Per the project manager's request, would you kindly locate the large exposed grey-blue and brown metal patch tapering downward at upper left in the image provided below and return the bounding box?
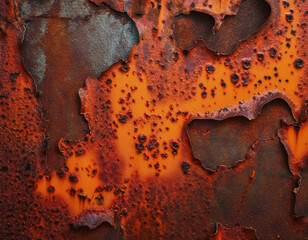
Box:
[20,0,138,169]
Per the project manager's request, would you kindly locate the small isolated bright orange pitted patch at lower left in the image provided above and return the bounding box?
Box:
[37,150,114,215]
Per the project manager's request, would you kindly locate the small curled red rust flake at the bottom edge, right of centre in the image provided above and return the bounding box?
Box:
[210,223,257,240]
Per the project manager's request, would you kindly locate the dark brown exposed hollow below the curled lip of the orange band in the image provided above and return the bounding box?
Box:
[187,100,294,170]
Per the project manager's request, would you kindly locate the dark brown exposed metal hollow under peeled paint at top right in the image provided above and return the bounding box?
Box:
[174,0,271,55]
